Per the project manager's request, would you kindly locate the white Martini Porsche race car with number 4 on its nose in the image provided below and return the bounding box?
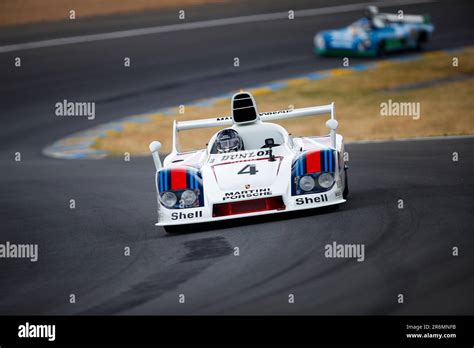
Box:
[150,92,349,232]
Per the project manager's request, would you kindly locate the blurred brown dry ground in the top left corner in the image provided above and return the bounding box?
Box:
[0,0,225,26]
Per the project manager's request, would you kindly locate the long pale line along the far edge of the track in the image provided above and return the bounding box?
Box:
[0,0,434,53]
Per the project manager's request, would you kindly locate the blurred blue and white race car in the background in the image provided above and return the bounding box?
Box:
[314,6,434,56]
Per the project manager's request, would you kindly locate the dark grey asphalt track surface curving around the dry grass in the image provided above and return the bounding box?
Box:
[0,1,474,314]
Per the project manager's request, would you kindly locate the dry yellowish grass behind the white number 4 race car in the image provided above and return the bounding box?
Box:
[96,48,474,154]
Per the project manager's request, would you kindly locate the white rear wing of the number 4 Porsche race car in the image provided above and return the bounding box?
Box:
[173,103,338,152]
